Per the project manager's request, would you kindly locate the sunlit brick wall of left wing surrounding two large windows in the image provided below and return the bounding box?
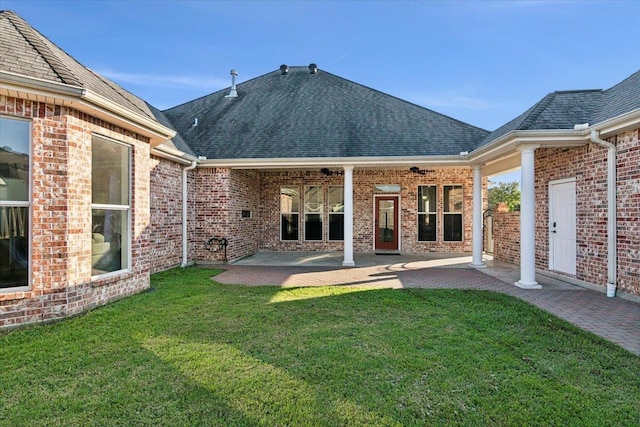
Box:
[0,96,149,328]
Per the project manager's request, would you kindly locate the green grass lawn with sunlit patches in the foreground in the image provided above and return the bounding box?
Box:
[0,268,640,426]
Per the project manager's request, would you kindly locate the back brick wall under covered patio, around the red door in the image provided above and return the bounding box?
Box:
[260,169,486,253]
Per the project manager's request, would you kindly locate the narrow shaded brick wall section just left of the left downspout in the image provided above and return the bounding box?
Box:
[149,156,184,273]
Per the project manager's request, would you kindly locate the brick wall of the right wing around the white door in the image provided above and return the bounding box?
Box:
[535,129,640,295]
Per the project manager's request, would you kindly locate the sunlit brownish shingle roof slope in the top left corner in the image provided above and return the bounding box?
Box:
[0,11,155,122]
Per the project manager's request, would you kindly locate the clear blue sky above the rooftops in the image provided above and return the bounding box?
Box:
[5,0,640,182]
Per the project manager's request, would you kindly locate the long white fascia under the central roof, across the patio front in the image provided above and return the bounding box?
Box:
[198,156,469,169]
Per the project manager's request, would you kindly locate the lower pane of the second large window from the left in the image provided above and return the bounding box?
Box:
[91,209,129,276]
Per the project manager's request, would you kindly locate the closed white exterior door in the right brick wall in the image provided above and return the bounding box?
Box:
[549,179,576,275]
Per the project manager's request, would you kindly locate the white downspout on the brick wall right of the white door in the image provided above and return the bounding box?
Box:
[591,130,618,297]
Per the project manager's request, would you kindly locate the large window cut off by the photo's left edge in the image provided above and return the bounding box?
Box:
[0,117,31,289]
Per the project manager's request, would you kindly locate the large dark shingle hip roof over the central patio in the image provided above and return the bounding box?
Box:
[164,67,487,159]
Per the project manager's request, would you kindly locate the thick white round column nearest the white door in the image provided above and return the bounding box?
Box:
[515,146,542,289]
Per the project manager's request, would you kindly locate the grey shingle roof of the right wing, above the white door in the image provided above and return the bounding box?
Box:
[480,71,640,145]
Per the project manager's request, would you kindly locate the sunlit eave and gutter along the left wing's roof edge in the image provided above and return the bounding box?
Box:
[0,71,176,146]
